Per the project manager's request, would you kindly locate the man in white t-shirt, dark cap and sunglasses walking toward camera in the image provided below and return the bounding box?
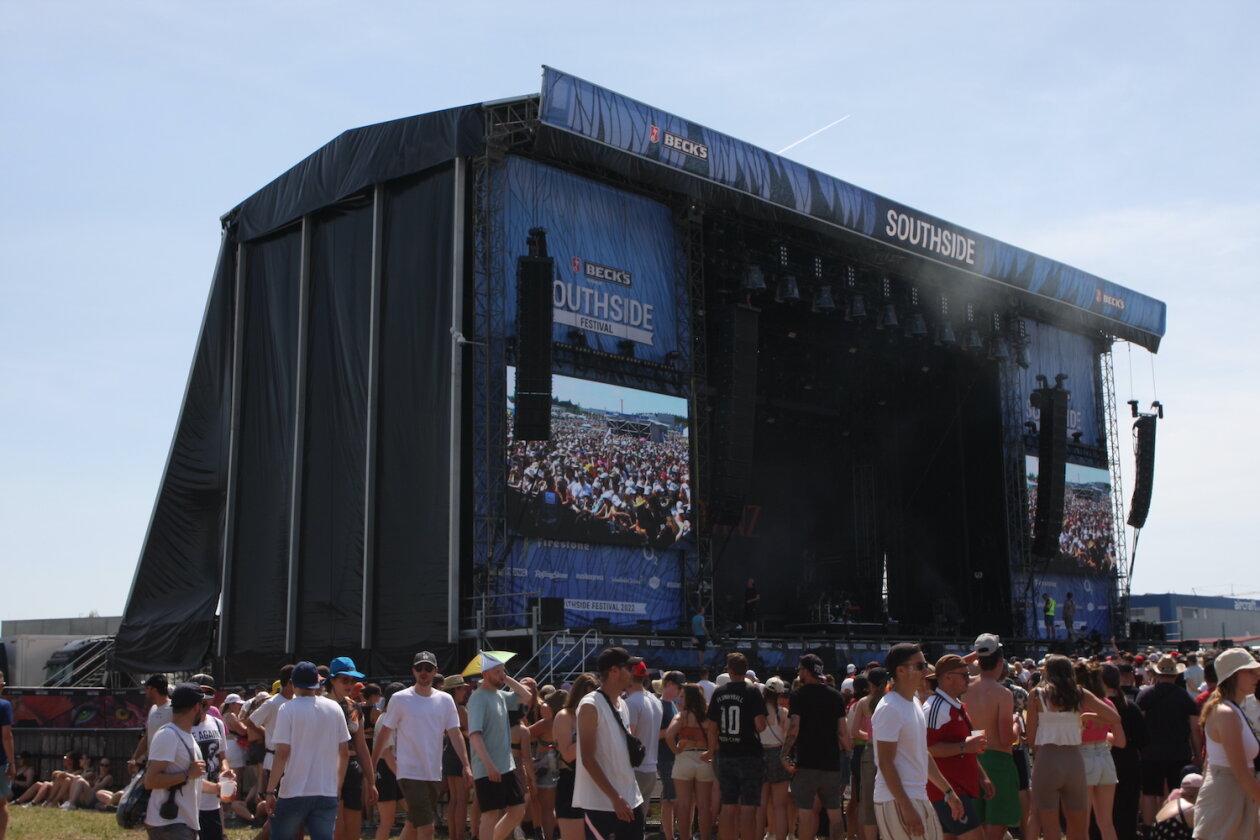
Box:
[372,650,473,840]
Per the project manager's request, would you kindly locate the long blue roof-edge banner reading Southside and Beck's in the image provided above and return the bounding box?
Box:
[539,68,1167,349]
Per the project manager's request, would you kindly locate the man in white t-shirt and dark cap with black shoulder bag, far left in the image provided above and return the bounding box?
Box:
[145,684,205,840]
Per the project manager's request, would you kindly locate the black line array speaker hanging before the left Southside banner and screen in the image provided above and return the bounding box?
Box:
[514,228,554,441]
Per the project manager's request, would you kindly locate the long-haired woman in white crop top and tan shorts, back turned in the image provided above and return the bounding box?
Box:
[1028,654,1120,840]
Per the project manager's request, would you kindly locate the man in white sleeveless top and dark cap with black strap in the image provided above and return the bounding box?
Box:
[573,647,644,840]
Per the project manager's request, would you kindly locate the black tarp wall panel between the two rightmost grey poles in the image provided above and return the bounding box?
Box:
[369,170,455,674]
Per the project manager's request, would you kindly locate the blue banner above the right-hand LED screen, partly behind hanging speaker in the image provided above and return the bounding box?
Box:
[1019,321,1105,447]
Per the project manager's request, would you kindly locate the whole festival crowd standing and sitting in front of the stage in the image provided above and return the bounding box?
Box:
[5,633,1260,840]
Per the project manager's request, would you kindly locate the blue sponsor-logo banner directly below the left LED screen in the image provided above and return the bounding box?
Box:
[503,536,683,630]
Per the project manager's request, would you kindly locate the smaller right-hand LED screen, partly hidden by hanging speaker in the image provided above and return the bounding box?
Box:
[1024,455,1115,572]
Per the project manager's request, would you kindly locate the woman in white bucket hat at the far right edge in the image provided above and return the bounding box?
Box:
[1194,647,1260,840]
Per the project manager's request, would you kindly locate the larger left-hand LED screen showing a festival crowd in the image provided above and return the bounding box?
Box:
[507,368,693,548]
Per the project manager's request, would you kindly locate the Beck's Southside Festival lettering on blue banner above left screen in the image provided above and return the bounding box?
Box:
[552,257,656,346]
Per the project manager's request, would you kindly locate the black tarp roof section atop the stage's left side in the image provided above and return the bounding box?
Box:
[223,105,485,242]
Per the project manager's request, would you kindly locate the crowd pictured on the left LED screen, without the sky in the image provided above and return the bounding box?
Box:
[507,412,692,548]
